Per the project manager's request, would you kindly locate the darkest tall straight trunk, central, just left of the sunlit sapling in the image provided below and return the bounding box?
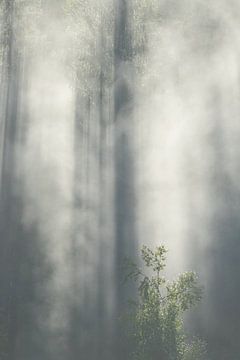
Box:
[114,0,137,358]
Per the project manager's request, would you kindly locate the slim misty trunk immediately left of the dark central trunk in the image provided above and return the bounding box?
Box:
[97,27,114,360]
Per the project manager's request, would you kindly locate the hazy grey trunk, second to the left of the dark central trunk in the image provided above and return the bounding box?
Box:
[69,83,94,360]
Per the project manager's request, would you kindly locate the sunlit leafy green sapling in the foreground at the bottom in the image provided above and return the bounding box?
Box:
[123,246,206,360]
